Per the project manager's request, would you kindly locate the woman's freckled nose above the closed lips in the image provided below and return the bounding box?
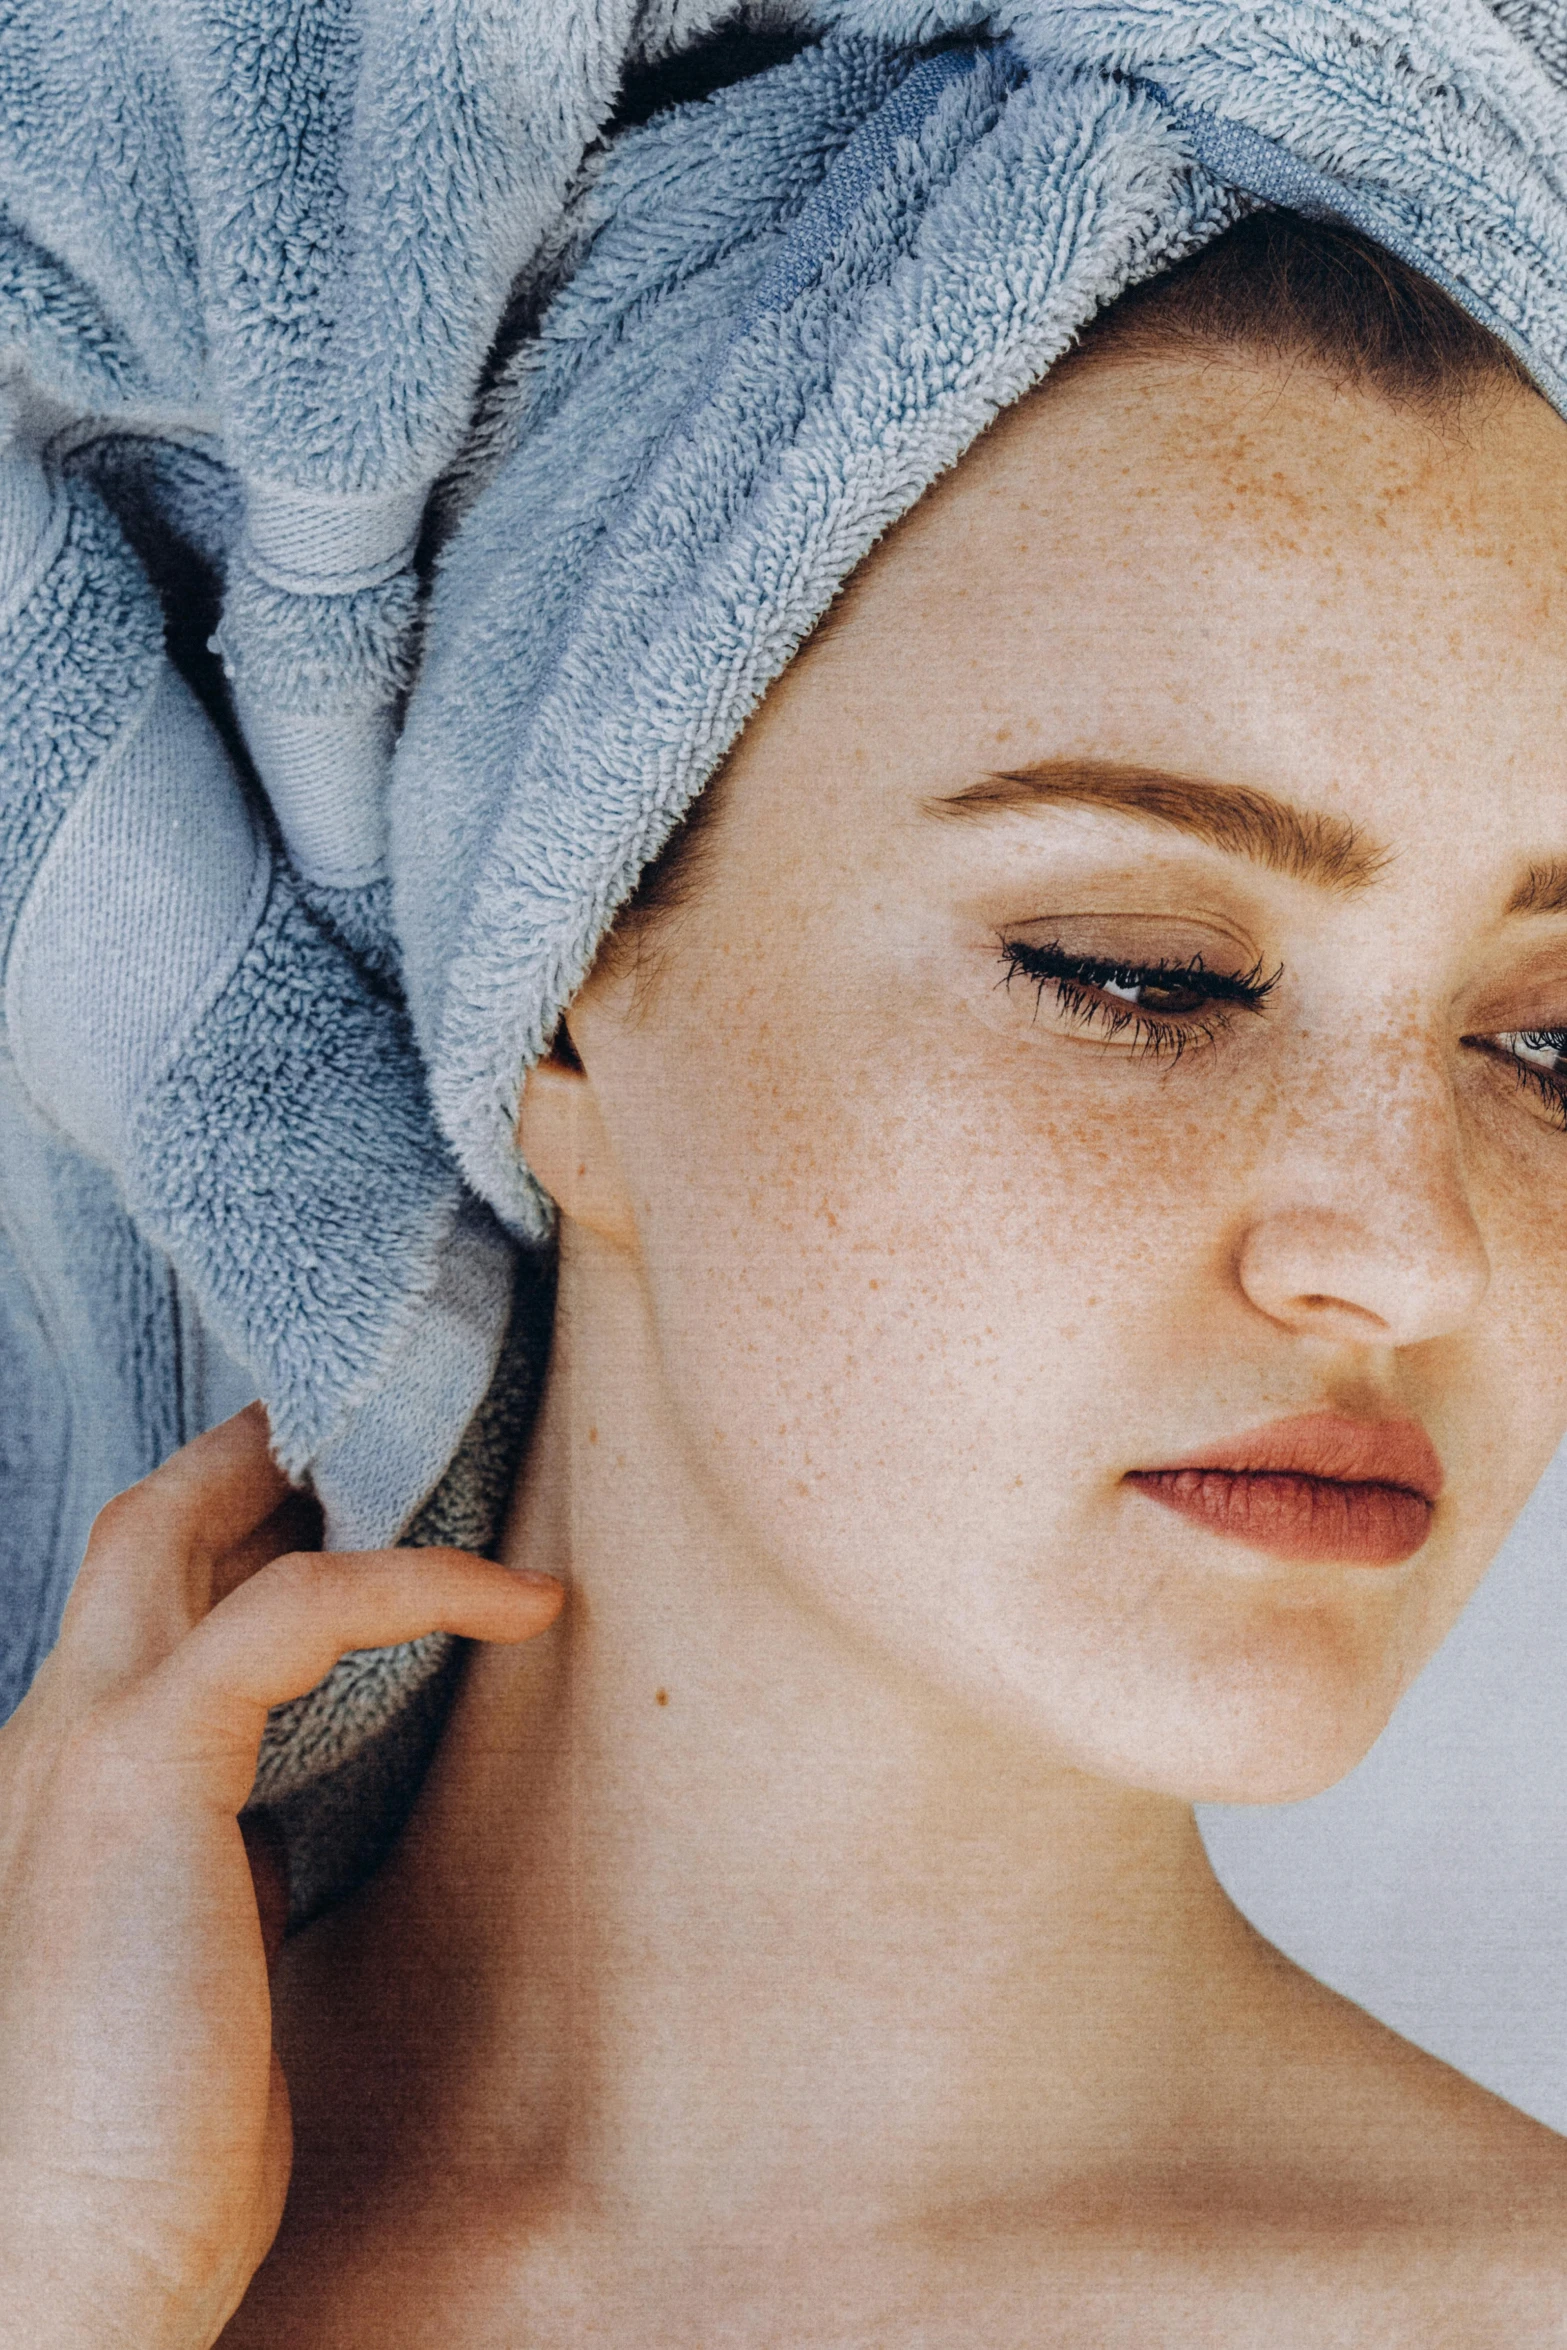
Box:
[1236,1088,1489,1347]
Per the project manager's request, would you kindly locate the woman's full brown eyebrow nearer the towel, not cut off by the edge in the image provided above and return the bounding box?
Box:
[926,759,1390,905]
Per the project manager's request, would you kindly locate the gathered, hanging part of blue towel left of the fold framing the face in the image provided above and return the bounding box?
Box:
[0,0,779,1544]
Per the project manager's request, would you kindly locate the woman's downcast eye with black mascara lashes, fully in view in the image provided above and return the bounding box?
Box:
[1001,938,1280,1055]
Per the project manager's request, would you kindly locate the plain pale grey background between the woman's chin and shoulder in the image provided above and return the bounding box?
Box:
[1198,1445,1567,2131]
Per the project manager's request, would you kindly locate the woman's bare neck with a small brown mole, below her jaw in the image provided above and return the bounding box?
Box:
[312,1253,1257,2242]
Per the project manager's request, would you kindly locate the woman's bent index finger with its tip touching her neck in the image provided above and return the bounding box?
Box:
[139,1549,564,1810]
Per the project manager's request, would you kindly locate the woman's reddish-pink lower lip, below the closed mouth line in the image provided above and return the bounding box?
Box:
[1125,1469,1431,1567]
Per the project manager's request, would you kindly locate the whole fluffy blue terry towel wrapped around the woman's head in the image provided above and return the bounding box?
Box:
[0,0,1567,1802]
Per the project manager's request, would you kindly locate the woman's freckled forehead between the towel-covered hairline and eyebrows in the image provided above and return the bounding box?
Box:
[738,355,1567,864]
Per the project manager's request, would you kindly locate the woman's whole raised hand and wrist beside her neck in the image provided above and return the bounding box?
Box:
[0,1405,561,2350]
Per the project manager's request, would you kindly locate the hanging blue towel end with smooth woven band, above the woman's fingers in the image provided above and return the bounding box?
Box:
[0,402,510,1542]
